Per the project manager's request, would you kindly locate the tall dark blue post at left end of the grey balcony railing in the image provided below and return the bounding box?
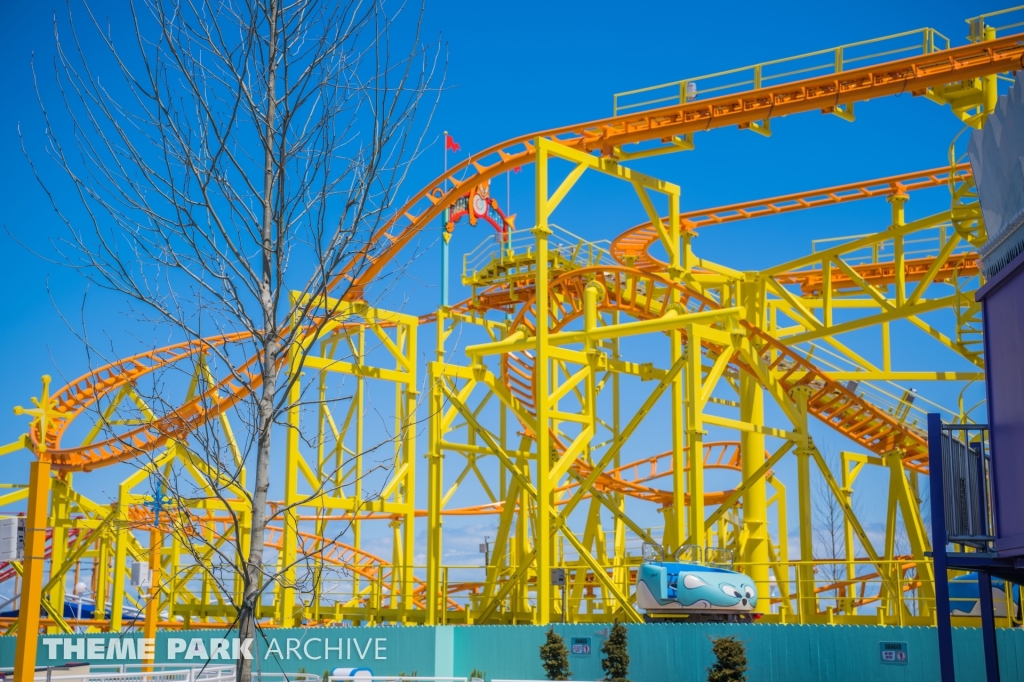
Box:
[928,414,954,682]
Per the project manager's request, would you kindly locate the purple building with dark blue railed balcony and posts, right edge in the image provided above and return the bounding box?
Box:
[928,242,1024,682]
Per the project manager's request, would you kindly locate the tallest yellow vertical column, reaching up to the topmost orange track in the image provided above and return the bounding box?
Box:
[534,138,554,625]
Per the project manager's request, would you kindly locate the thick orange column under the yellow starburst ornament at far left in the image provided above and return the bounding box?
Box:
[14,461,50,682]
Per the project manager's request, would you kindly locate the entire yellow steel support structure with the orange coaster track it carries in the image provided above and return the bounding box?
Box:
[0,13,1024,663]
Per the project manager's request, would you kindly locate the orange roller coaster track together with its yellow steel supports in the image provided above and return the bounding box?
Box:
[0,21,1011,647]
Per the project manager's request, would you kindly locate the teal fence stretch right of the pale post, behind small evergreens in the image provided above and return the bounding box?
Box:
[455,624,1024,682]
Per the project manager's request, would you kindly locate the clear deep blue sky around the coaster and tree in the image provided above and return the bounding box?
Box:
[0,0,1004,561]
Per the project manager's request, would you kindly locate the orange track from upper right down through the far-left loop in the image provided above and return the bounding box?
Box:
[29,35,1024,470]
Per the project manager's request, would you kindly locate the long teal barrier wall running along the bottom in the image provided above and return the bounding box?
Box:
[0,624,1024,682]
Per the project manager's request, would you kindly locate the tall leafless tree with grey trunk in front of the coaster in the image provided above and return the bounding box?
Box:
[23,0,442,682]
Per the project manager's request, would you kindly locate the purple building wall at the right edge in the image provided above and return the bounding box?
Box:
[976,246,1024,557]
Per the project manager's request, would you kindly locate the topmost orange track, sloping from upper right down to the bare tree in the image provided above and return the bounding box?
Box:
[332,34,1024,300]
